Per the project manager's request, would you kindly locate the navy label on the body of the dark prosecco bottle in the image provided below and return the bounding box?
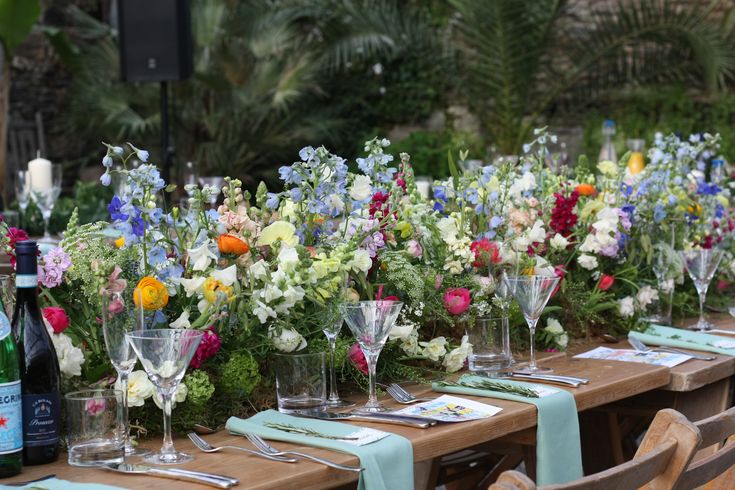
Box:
[23,393,61,446]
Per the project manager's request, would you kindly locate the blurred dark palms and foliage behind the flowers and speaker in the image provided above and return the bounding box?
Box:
[4,0,735,234]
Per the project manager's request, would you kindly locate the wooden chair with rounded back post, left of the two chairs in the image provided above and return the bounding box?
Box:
[488,408,702,490]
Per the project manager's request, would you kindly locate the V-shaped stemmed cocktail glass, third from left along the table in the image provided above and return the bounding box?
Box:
[503,275,559,374]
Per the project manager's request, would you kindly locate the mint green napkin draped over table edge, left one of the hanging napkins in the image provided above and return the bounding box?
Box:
[226,410,413,490]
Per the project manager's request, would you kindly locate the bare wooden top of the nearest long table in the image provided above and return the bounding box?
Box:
[0,356,669,490]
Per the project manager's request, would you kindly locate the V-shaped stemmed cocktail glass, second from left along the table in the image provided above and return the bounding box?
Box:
[339,301,403,412]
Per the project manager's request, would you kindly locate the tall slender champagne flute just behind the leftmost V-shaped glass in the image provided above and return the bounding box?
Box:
[100,289,150,456]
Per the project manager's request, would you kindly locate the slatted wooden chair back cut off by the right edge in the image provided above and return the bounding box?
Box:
[676,407,735,490]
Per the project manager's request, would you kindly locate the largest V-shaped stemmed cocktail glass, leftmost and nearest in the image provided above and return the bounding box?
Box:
[126,328,204,464]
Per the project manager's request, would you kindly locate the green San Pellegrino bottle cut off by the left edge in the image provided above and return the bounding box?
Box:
[0,290,23,478]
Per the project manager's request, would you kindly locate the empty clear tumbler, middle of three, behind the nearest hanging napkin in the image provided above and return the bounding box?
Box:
[275,352,327,413]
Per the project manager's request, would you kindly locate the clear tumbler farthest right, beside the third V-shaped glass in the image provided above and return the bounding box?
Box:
[466,318,510,376]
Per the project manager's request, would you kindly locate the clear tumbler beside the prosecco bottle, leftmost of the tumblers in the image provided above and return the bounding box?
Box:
[64,390,125,466]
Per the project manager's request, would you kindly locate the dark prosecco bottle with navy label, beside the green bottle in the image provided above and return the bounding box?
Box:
[12,240,61,465]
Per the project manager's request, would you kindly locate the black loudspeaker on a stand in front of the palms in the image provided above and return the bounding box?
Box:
[118,0,193,82]
